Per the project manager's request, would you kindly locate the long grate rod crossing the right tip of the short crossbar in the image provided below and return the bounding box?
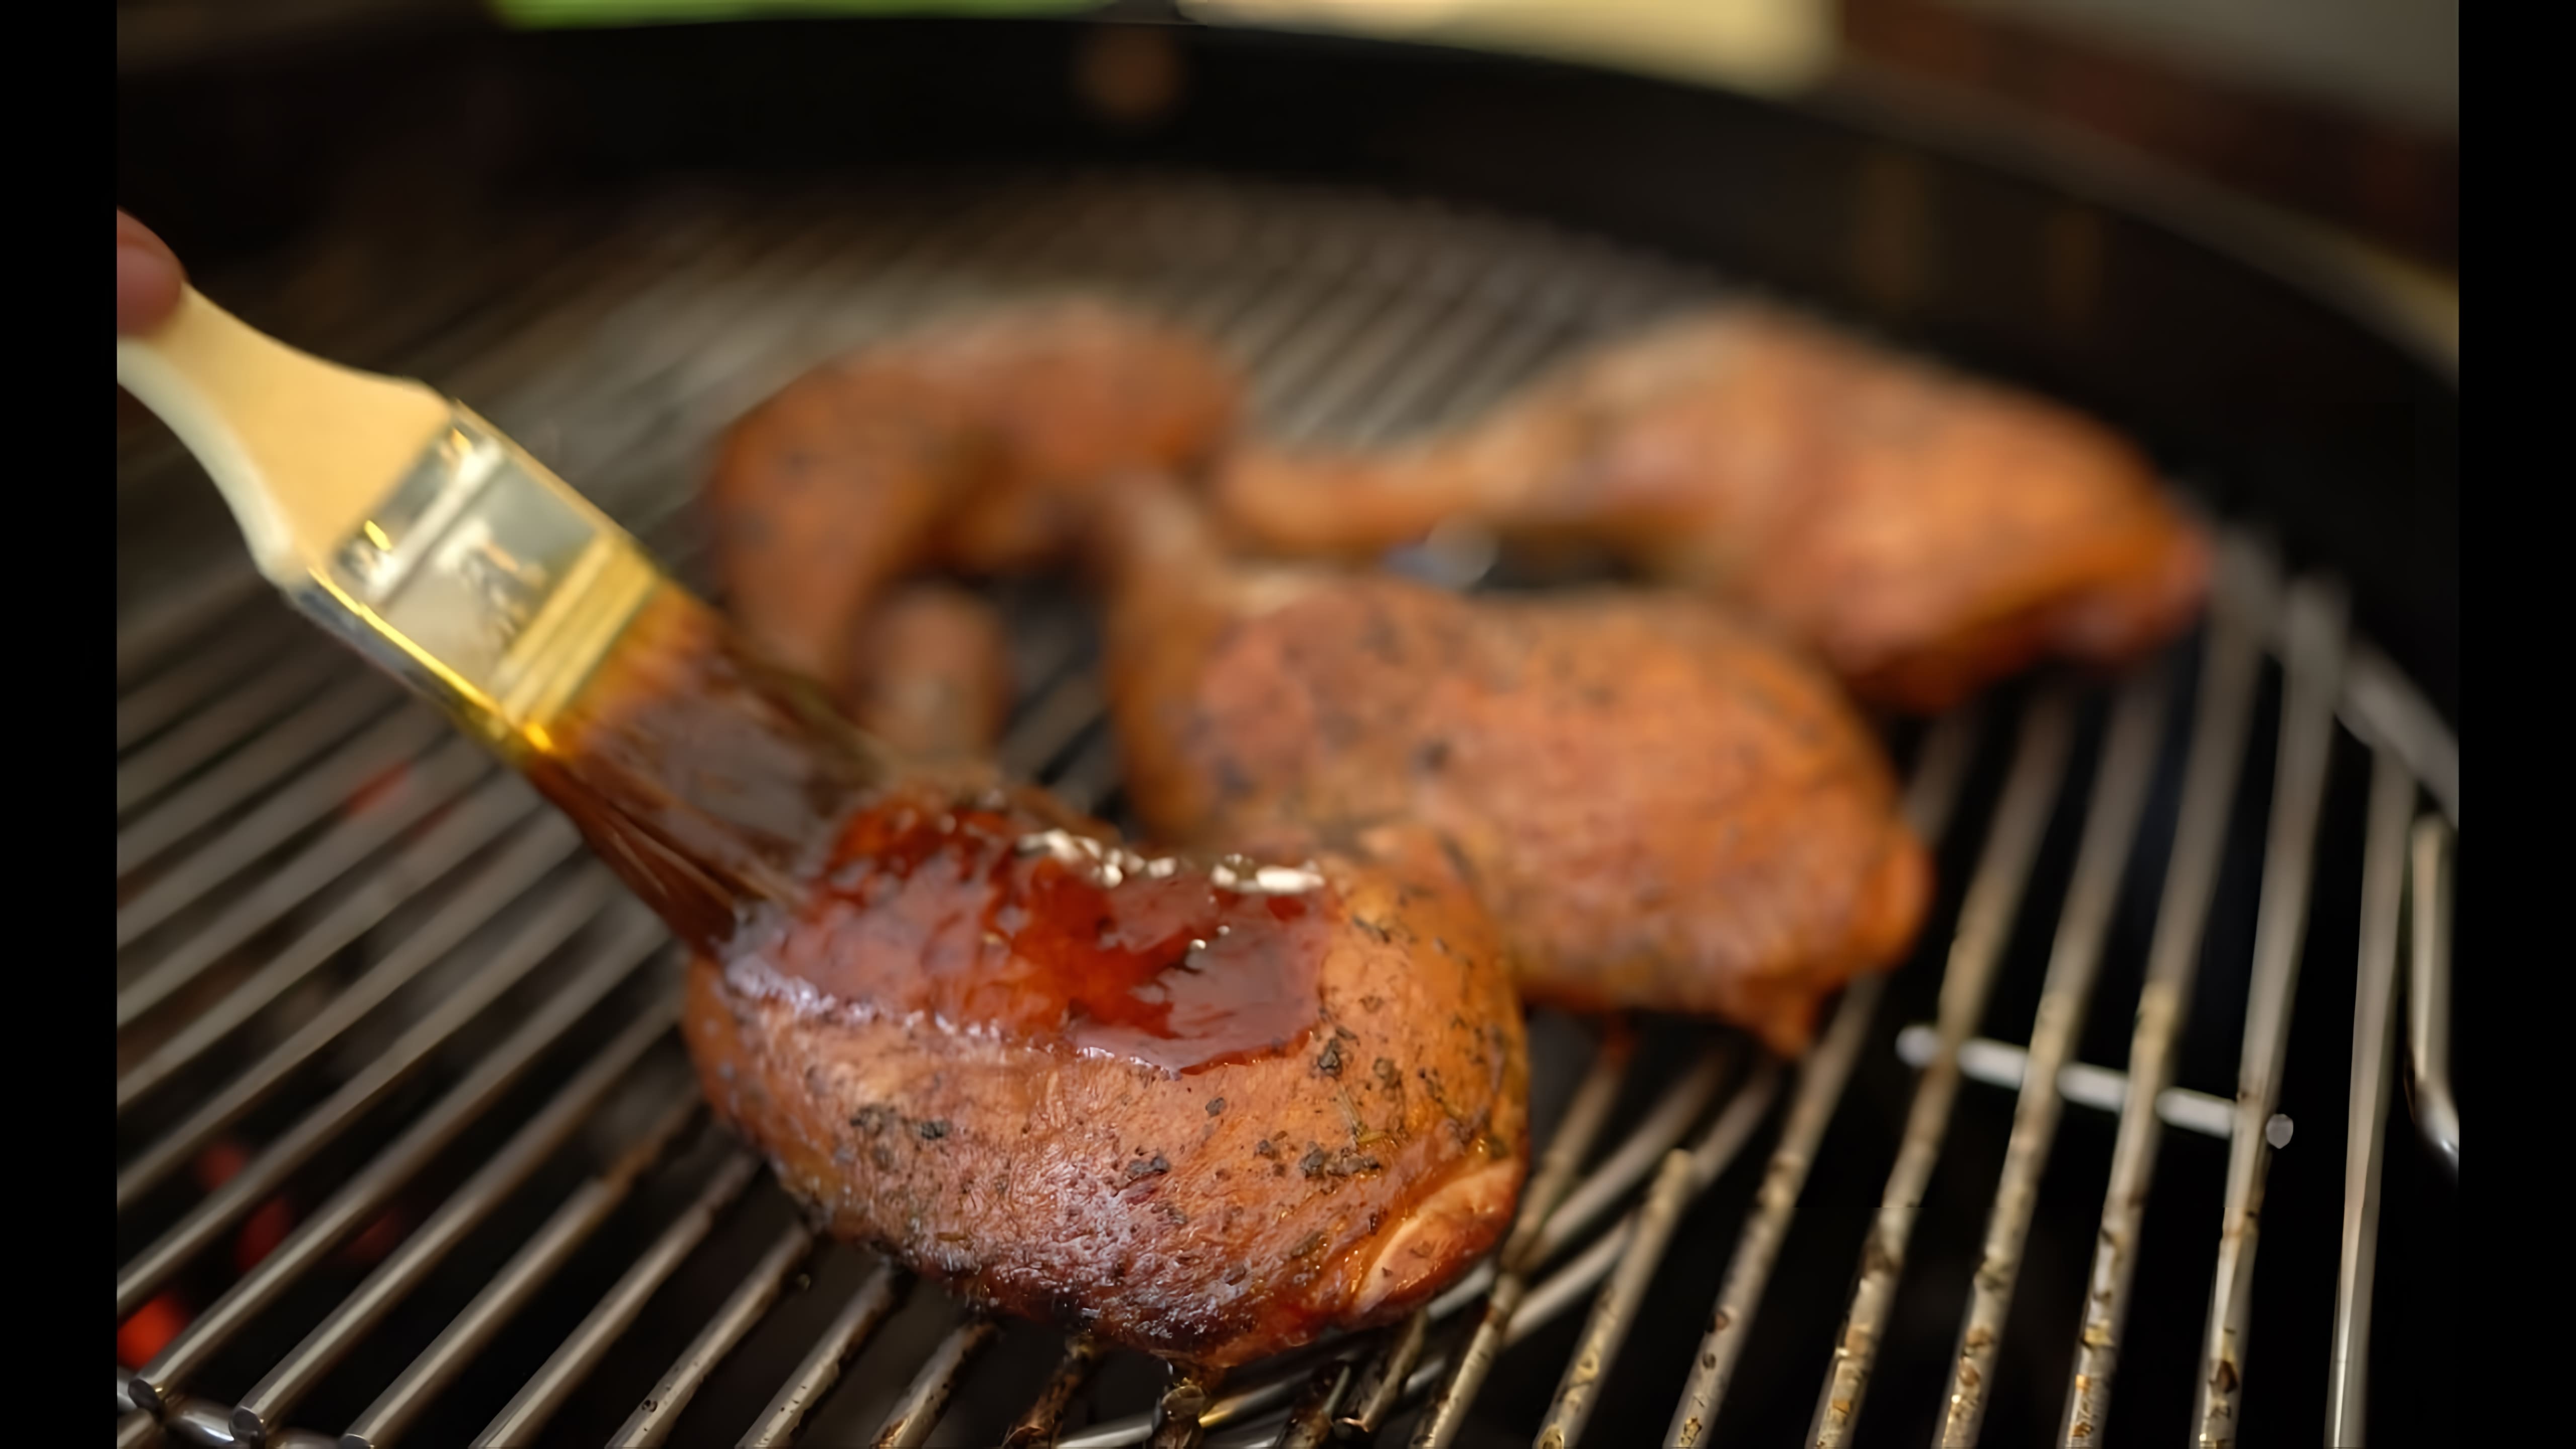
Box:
[2192,572,2349,1449]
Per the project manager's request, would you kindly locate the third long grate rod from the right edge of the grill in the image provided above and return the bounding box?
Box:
[2061,541,2272,1449]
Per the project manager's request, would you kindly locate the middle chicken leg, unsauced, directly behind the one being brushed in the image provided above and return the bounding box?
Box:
[1100,482,1929,1052]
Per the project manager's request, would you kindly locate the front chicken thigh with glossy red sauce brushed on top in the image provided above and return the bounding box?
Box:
[685,778,1527,1369]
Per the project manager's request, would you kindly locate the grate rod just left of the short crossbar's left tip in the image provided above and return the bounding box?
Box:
[1664,706,1978,1449]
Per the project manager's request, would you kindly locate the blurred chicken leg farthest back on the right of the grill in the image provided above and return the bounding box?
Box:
[1219,307,2208,711]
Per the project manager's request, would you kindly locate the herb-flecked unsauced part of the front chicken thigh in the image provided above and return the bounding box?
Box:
[683,815,1527,1369]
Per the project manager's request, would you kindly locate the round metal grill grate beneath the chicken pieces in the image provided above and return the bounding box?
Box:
[116,178,2457,1449]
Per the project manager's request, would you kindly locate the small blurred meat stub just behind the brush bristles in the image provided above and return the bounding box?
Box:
[850,583,1010,761]
